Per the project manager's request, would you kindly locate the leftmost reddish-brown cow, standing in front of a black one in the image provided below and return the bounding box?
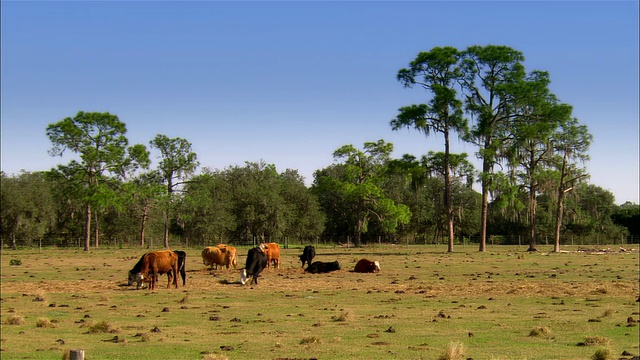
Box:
[129,250,178,290]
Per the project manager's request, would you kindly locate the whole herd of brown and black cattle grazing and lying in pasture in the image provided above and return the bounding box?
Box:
[128,243,380,290]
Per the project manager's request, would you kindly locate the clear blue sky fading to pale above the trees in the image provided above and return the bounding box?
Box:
[1,0,640,204]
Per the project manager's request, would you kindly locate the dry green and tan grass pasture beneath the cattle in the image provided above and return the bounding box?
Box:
[0,245,640,360]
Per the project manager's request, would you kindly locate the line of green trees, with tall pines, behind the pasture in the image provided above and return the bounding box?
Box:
[0,45,640,251]
